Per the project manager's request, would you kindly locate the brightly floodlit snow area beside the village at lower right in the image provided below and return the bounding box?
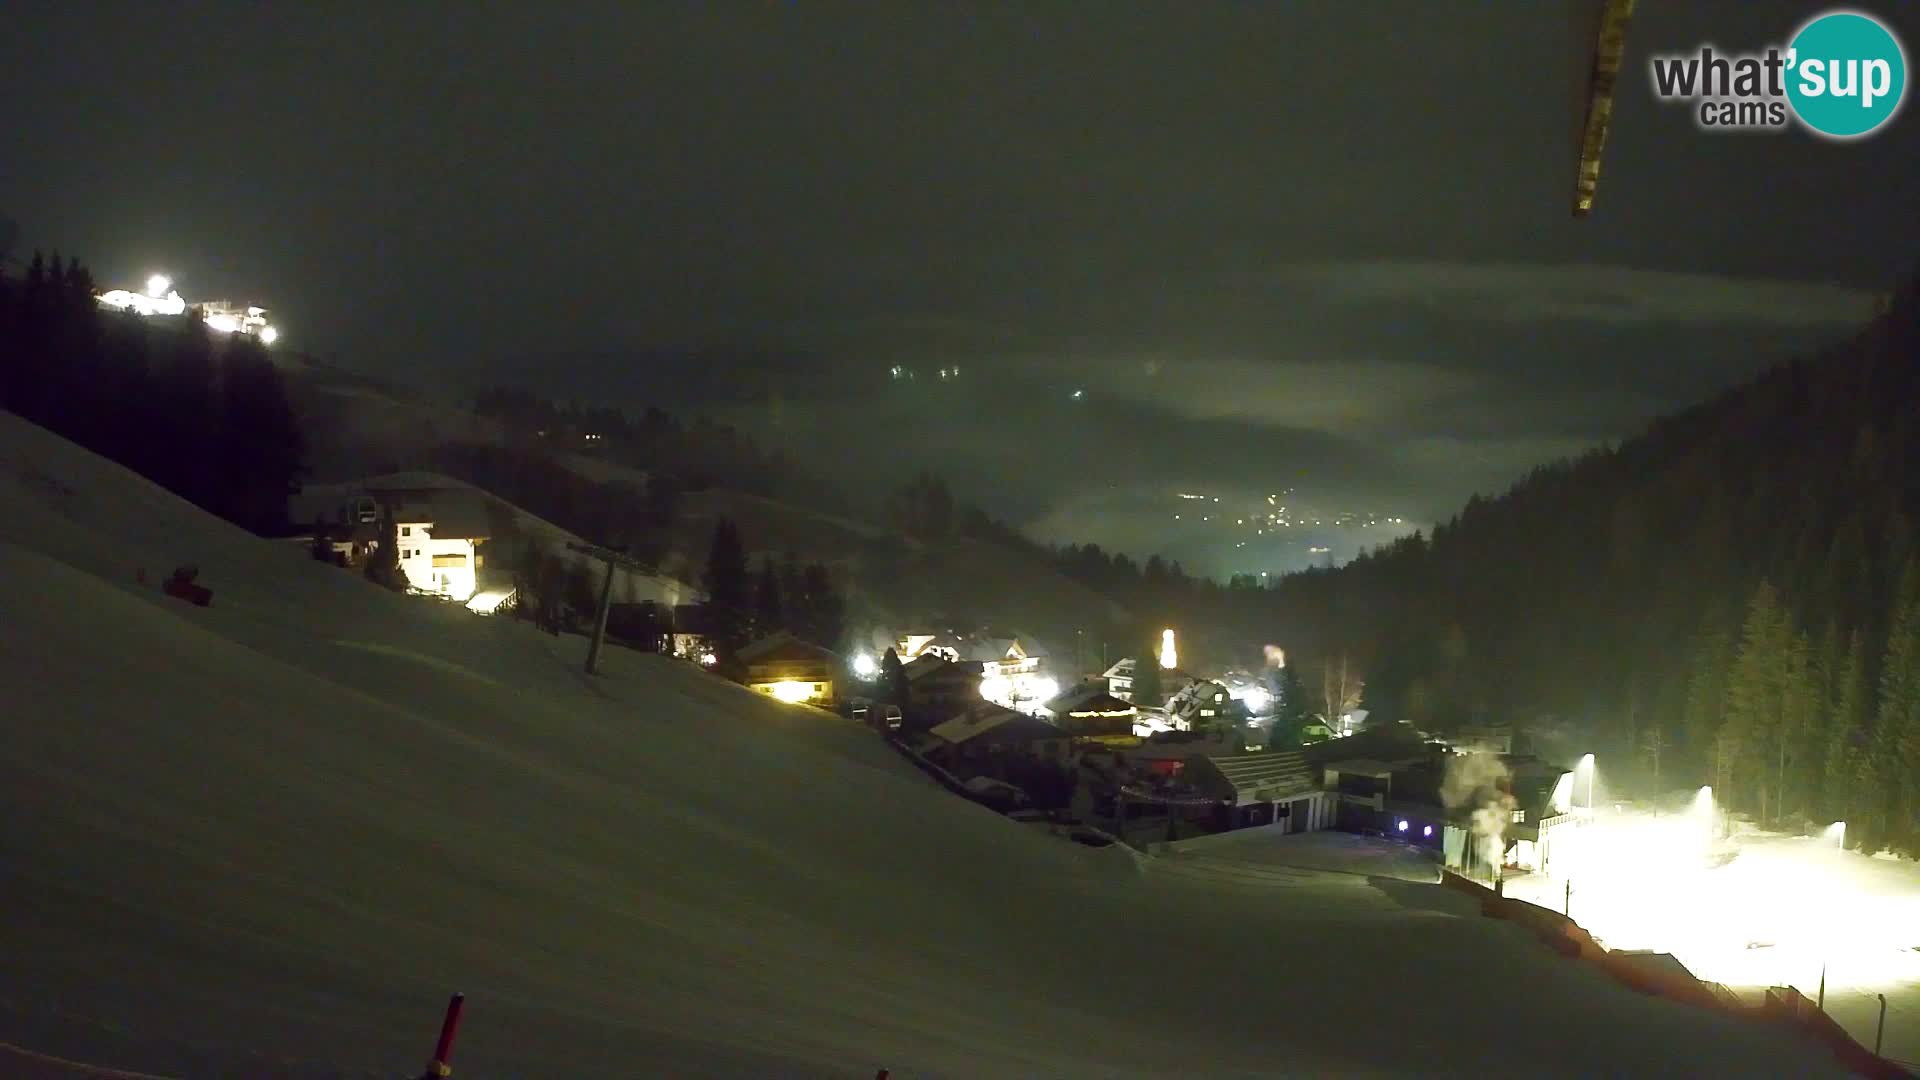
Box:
[1503,788,1920,1061]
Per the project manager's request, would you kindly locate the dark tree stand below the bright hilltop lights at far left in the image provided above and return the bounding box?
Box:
[0,252,305,534]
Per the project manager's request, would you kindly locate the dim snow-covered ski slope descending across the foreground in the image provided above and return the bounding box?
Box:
[0,413,1834,1078]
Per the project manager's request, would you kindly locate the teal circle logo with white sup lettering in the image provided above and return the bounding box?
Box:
[1788,12,1907,138]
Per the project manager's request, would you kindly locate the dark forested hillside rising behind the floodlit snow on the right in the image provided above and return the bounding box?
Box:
[1277,265,1920,847]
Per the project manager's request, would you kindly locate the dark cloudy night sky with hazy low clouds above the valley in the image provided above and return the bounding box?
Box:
[0,0,1920,573]
